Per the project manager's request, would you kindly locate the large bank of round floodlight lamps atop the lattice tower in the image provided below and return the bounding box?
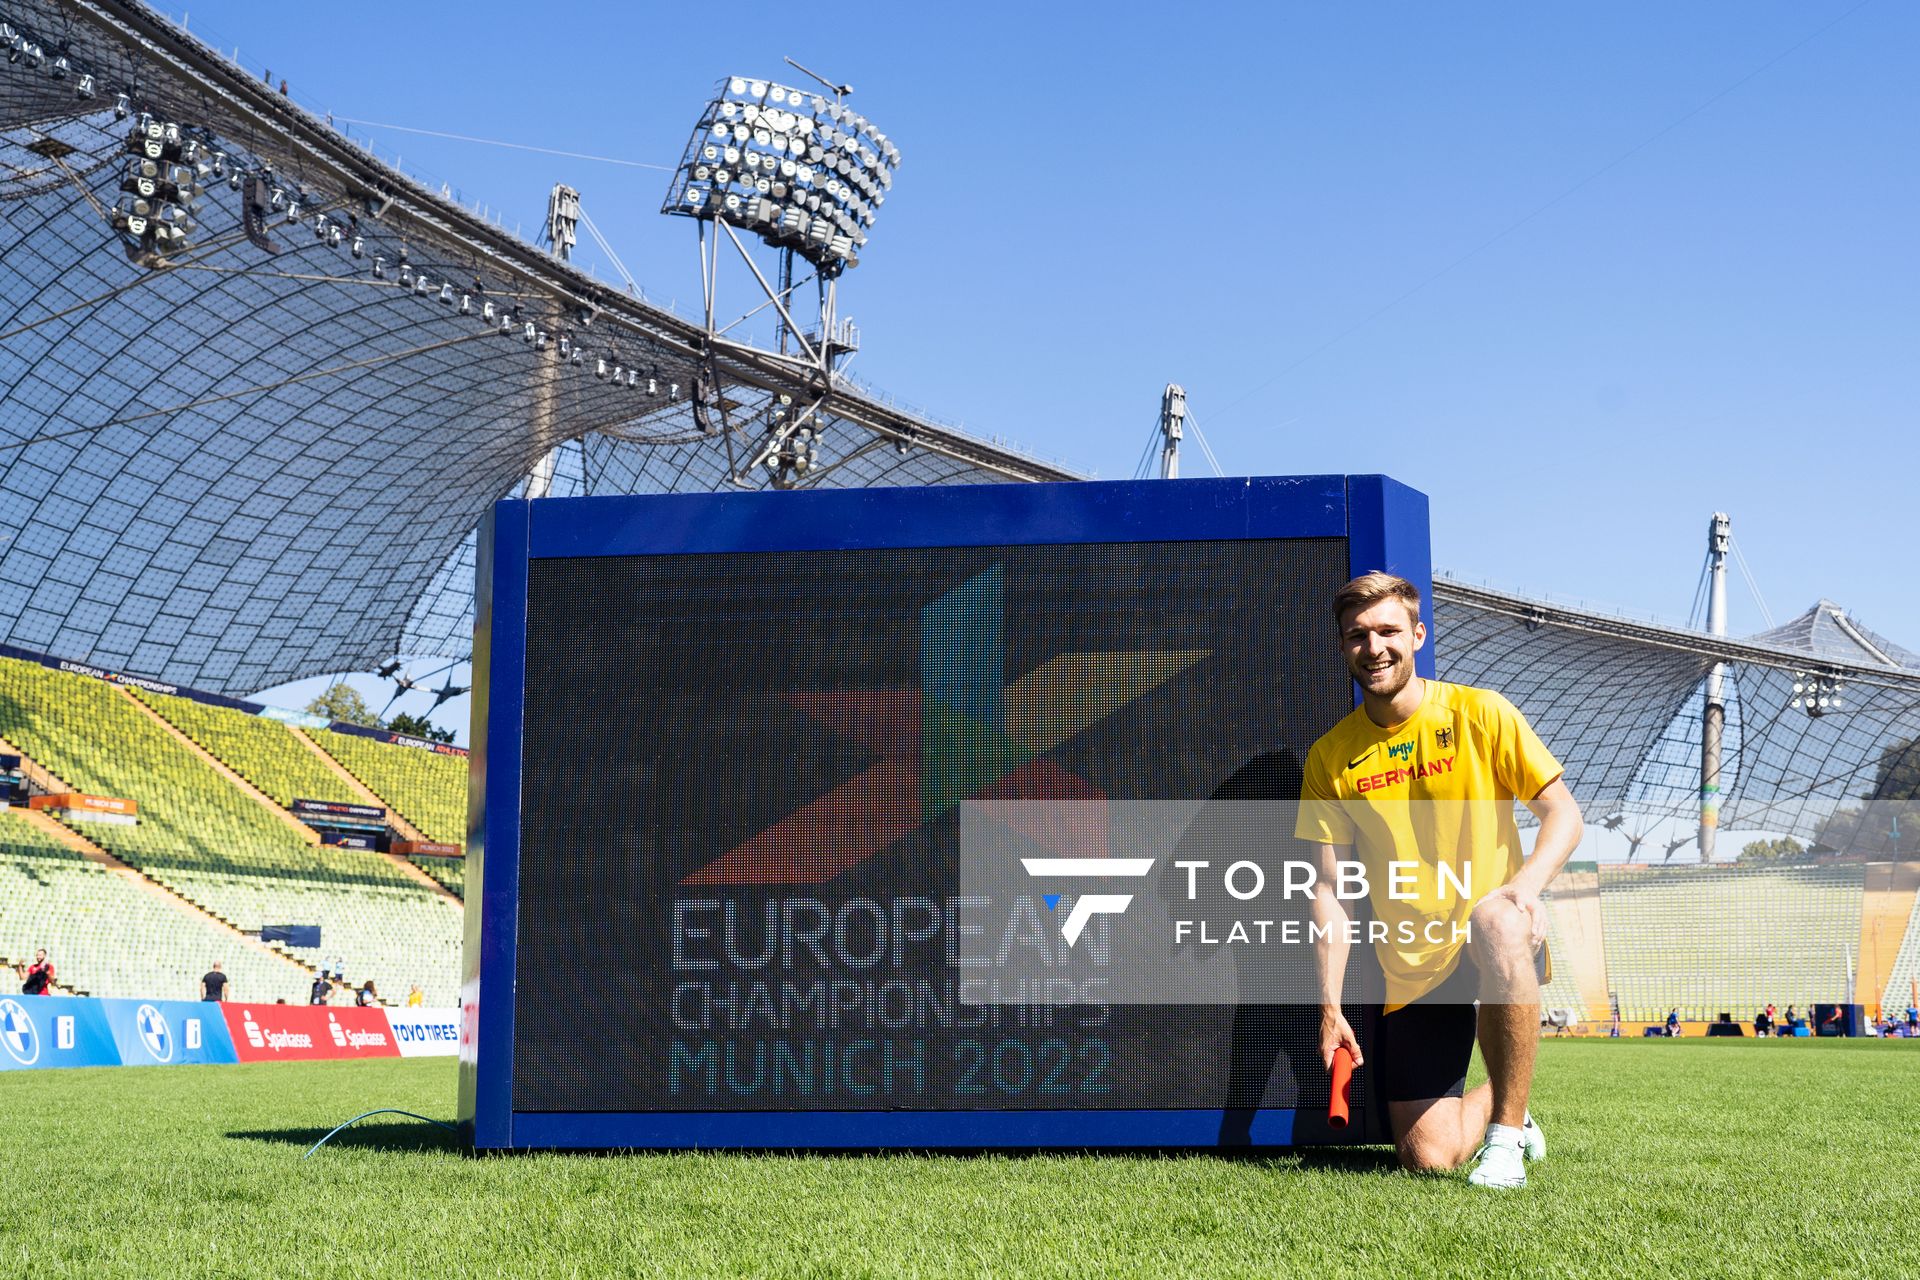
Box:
[660,77,900,278]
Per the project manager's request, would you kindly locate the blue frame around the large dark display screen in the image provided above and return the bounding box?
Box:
[459,476,1434,1151]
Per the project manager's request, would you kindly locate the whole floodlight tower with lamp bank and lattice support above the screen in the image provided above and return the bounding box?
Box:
[660,58,900,487]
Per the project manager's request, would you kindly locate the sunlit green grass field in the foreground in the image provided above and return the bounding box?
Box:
[0,1040,1920,1280]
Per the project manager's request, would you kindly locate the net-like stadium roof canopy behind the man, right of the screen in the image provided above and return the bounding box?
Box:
[1434,580,1920,844]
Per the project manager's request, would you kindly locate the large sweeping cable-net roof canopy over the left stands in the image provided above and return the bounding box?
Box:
[0,0,1064,693]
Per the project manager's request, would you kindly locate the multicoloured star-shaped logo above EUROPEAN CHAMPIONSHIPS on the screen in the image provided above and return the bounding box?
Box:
[680,564,1210,885]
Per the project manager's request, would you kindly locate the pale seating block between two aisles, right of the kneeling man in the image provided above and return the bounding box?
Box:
[1599,864,1862,1021]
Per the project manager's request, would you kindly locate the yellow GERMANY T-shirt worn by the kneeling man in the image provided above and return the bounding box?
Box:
[1294,679,1561,1011]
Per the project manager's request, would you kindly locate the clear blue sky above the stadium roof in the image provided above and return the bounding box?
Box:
[175,0,1920,736]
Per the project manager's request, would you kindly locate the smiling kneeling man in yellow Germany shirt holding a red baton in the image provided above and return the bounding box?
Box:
[1296,574,1584,1188]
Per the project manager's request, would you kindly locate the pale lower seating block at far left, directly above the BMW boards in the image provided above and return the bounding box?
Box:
[0,812,305,1000]
